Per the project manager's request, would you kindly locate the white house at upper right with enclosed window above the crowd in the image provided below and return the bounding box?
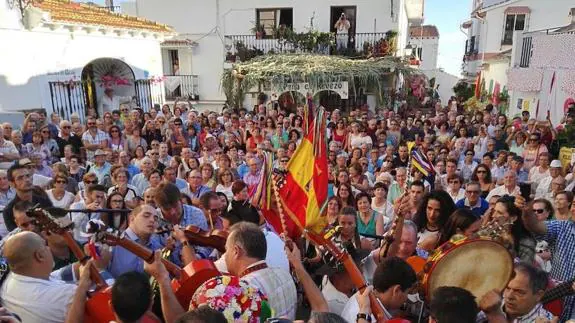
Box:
[461,0,575,110]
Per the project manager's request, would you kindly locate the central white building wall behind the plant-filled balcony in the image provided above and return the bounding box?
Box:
[122,0,424,109]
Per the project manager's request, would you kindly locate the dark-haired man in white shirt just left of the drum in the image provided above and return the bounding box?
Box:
[342,257,417,322]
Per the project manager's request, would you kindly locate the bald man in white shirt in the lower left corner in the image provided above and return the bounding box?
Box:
[0,232,92,323]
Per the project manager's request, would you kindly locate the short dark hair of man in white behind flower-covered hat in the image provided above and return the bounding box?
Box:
[229,221,267,260]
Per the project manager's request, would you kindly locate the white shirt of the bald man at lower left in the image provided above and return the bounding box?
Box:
[0,272,76,323]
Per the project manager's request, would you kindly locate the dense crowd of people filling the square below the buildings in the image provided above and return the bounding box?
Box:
[0,98,575,323]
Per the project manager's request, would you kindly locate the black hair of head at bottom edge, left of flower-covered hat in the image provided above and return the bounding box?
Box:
[112,271,152,322]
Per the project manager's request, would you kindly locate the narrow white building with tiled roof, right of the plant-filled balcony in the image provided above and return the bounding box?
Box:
[408,25,459,104]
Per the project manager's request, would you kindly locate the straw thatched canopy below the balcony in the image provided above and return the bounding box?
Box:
[222,54,416,107]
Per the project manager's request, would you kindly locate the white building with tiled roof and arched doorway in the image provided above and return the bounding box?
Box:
[0,0,174,121]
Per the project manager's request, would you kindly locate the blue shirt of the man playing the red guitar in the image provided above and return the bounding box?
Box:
[108,228,162,277]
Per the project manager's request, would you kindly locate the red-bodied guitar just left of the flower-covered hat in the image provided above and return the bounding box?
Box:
[92,231,221,308]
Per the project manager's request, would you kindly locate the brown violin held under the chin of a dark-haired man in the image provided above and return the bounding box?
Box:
[156,218,229,253]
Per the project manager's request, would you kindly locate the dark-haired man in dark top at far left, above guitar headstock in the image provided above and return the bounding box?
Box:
[2,159,52,231]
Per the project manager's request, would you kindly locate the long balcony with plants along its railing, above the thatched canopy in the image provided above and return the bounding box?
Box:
[226,32,397,62]
